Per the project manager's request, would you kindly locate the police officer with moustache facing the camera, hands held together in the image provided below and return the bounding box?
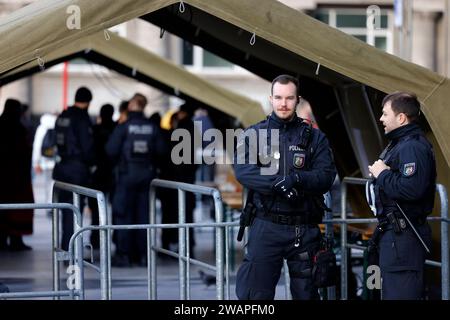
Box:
[234,75,336,300]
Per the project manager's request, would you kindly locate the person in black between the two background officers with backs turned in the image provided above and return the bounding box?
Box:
[88,104,116,249]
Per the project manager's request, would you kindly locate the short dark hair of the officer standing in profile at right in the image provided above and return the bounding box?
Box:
[381,91,420,122]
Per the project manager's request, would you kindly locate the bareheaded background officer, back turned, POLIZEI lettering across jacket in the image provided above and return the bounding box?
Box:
[106,93,166,267]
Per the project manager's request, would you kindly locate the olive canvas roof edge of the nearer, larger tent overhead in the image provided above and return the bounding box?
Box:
[0,0,450,166]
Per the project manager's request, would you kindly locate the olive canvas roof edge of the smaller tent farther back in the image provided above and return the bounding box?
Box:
[0,32,265,126]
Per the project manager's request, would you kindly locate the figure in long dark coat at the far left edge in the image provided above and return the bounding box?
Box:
[0,99,34,251]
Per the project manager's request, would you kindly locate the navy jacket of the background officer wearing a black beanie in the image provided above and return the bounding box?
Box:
[53,107,95,186]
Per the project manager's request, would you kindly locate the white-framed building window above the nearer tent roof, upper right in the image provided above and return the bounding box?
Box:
[314,8,394,53]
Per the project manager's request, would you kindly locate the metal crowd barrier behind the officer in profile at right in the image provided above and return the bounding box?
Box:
[336,177,450,300]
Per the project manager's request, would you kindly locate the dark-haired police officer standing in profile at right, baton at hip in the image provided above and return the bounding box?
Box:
[369,92,436,300]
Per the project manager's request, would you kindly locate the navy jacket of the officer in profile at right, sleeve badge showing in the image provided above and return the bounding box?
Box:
[374,123,436,222]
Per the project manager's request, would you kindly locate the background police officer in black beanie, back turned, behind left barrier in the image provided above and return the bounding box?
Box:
[53,87,95,250]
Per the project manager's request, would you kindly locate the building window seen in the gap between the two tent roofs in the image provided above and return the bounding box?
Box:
[181,40,236,71]
